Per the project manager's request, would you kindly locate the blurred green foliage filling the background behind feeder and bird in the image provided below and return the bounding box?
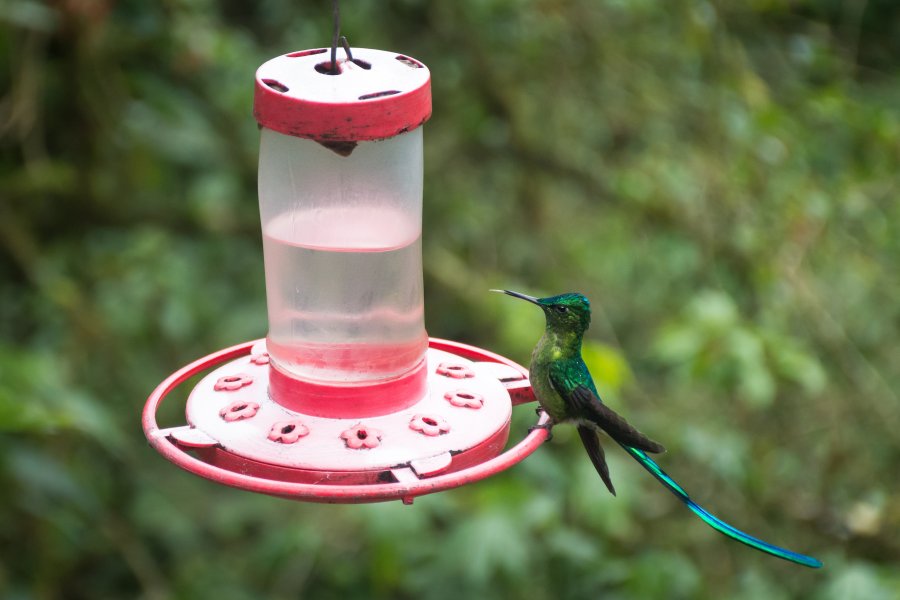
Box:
[0,0,900,600]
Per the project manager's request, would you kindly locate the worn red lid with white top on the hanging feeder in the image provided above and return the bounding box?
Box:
[253,48,431,141]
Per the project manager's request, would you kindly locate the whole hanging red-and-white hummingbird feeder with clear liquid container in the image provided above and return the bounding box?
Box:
[143,34,547,503]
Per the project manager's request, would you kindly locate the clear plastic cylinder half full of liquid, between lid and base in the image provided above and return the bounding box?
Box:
[259,127,428,384]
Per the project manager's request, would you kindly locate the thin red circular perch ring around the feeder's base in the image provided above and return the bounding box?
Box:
[142,338,548,504]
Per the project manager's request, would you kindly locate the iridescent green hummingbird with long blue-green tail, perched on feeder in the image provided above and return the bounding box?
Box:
[491,290,822,568]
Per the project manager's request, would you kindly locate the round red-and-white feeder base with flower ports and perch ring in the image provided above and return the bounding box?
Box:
[143,339,547,503]
